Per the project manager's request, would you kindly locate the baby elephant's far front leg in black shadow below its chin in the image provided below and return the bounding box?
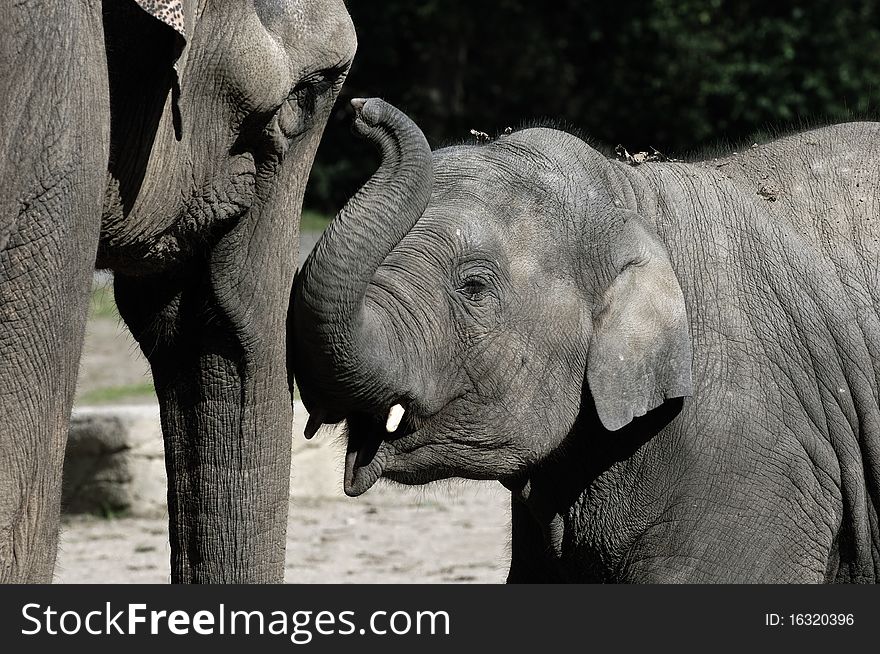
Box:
[507,494,562,584]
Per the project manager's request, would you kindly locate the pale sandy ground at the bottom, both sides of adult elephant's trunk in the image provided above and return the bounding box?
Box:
[55,485,508,583]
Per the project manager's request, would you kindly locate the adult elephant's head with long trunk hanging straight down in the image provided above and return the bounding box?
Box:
[99,0,356,581]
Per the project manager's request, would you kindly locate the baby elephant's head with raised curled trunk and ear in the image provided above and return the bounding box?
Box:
[290,99,691,495]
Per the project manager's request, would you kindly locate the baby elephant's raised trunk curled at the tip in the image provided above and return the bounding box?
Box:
[288,98,433,422]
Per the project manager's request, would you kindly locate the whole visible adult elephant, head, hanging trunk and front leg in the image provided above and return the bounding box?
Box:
[0,0,355,582]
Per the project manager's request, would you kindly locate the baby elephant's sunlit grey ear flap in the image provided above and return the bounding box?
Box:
[587,212,693,431]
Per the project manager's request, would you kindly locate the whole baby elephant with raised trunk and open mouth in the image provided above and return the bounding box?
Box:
[289,99,880,582]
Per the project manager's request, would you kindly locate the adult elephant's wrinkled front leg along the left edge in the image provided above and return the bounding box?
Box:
[0,2,109,583]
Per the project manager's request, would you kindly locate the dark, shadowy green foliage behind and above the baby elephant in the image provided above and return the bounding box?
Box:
[305,0,880,215]
